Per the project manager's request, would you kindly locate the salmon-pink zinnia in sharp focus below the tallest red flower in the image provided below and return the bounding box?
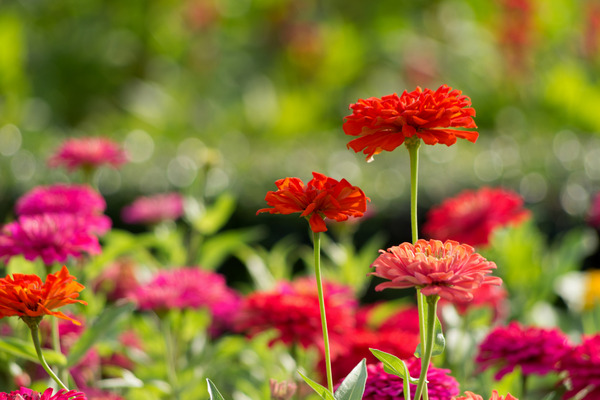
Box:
[370,239,502,301]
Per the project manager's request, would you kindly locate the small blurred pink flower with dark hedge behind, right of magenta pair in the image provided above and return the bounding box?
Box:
[121,193,183,225]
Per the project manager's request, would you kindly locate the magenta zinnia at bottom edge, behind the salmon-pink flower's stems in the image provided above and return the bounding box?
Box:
[362,357,459,400]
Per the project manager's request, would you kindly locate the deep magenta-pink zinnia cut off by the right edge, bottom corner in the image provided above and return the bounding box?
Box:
[559,334,600,400]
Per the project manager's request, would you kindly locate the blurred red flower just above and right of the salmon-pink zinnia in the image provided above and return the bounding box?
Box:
[423,187,530,246]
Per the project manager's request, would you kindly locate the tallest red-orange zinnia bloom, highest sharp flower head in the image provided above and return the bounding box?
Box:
[343,85,479,160]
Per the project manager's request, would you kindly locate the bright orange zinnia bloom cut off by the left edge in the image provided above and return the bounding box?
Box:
[0,266,87,325]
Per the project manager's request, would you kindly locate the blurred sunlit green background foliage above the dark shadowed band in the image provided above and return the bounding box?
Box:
[0,0,600,238]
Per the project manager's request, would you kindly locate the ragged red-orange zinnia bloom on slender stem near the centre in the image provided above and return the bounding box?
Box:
[256,172,368,232]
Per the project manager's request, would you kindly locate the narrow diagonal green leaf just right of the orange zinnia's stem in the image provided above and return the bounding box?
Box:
[67,303,135,367]
